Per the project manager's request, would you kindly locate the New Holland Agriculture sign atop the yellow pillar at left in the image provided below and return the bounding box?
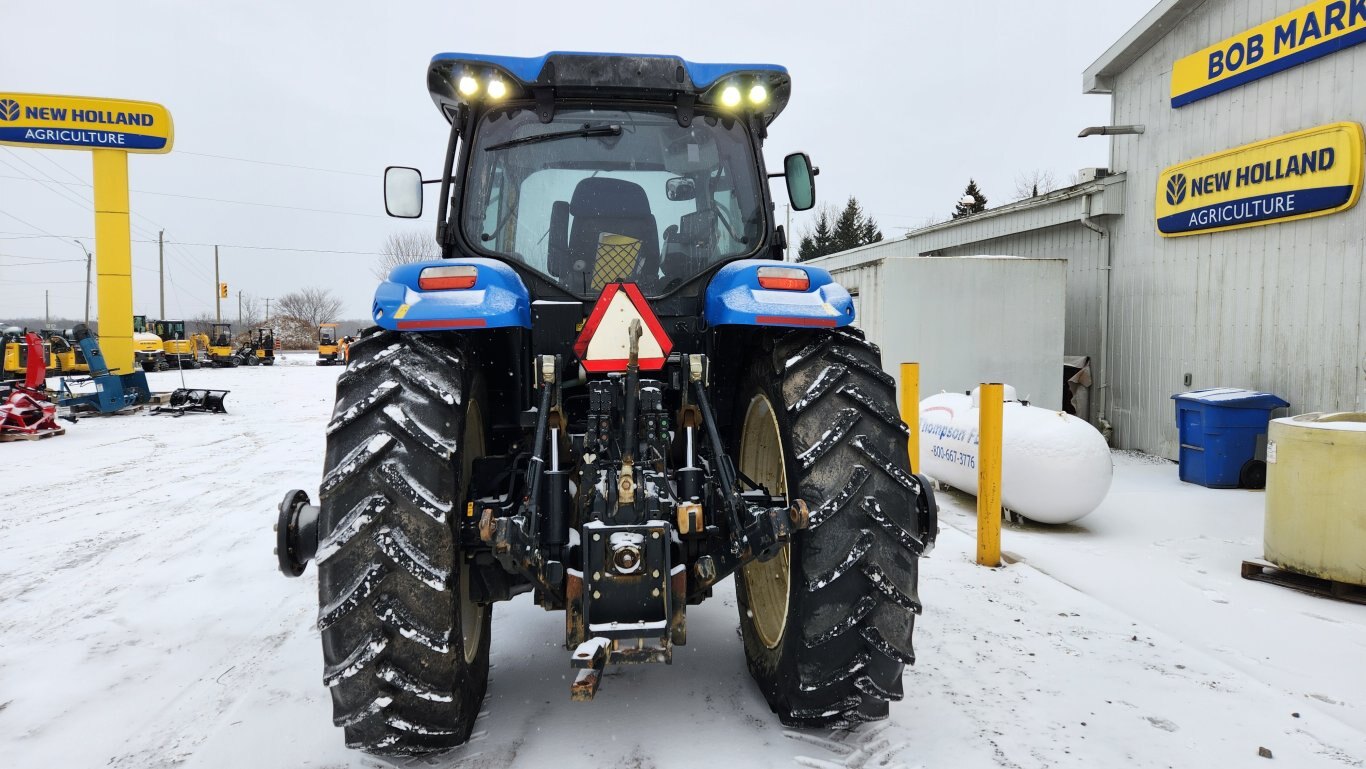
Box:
[0,93,175,153]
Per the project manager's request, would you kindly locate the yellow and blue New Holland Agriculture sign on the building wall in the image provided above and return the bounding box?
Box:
[1157,123,1366,238]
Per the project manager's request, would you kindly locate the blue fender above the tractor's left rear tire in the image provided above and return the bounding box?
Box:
[370,257,531,331]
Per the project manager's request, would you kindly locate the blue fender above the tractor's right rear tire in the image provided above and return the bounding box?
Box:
[706,260,854,328]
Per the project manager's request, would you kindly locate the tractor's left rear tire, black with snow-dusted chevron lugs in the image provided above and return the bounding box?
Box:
[317,332,492,755]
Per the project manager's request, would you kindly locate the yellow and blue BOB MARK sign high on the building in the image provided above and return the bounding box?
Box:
[1172,0,1366,108]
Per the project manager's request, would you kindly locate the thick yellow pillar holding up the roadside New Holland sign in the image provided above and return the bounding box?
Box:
[90,149,134,374]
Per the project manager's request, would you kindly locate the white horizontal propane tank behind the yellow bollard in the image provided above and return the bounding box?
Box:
[921,385,1115,523]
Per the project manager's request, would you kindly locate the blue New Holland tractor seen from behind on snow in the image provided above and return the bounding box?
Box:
[277,53,937,754]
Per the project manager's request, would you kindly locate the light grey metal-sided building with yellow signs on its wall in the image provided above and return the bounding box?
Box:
[819,0,1366,459]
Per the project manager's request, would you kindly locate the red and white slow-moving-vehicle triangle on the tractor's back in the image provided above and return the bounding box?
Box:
[574,283,673,374]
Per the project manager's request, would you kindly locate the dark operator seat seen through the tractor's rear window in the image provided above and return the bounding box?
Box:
[548,176,660,292]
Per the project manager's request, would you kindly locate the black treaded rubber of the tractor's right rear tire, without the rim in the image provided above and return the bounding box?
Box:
[742,329,925,728]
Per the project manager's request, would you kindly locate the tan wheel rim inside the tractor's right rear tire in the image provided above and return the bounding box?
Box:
[740,395,792,649]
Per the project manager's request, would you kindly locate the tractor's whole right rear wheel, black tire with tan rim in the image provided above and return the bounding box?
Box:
[732,331,933,727]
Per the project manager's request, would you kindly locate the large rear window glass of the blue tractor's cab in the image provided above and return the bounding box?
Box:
[462,108,764,296]
